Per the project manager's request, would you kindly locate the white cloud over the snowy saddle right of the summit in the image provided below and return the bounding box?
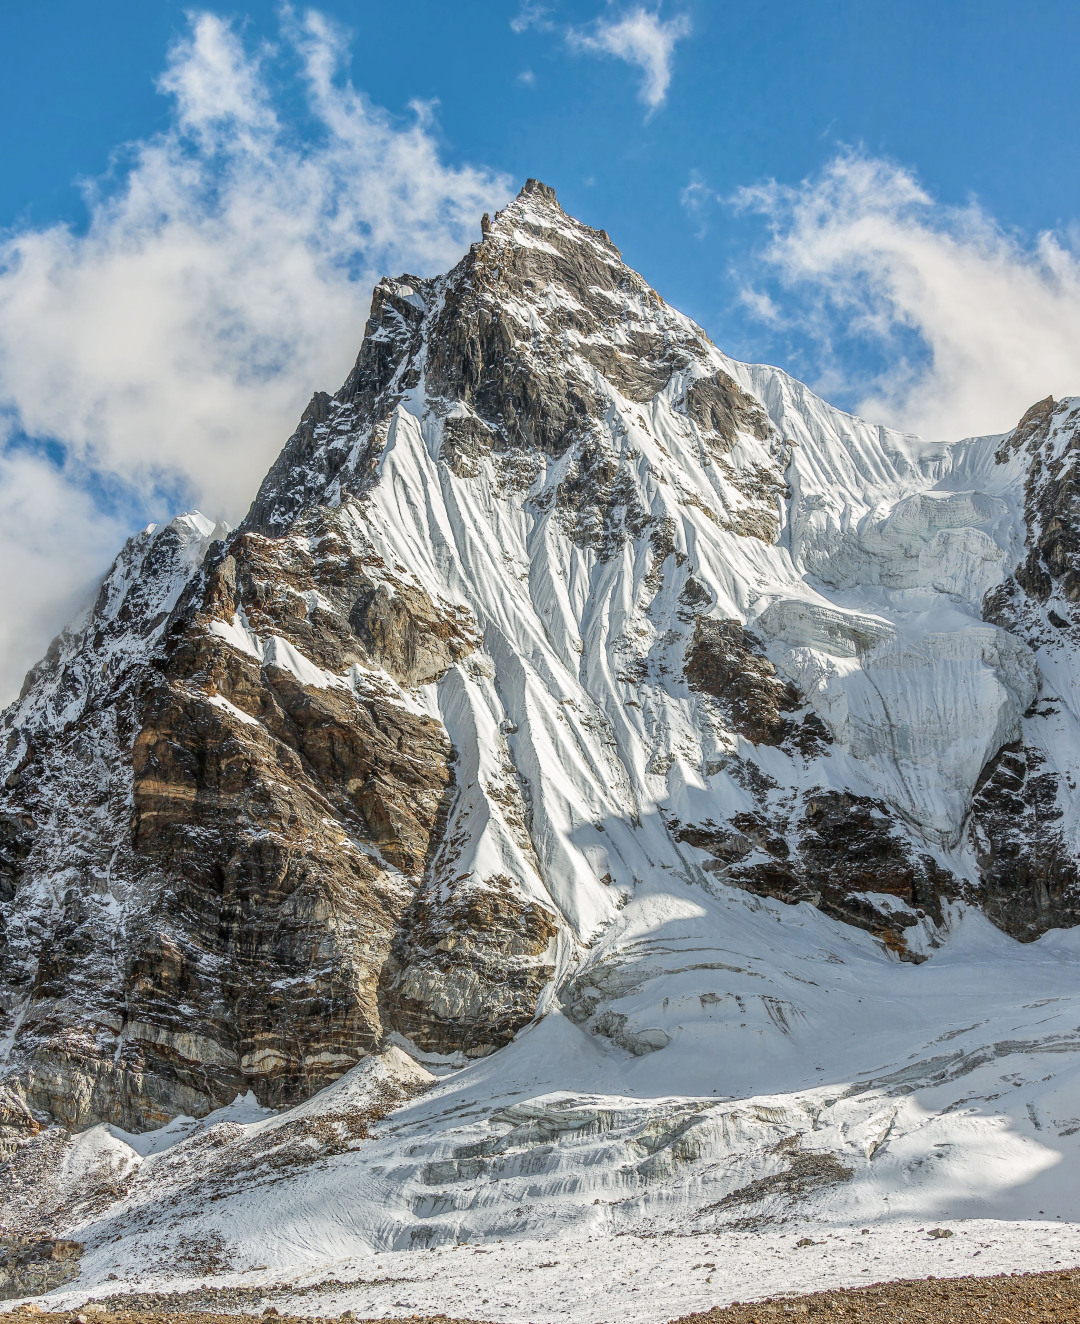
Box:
[735,152,1080,438]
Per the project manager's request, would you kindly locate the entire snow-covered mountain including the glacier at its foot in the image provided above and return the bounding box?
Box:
[0,181,1080,1317]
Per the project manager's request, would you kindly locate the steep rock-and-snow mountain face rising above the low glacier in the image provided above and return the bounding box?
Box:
[0,181,1080,1152]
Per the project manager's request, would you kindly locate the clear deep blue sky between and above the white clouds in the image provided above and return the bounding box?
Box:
[0,0,1080,365]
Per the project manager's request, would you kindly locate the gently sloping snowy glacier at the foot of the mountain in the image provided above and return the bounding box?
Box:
[16,894,1080,1324]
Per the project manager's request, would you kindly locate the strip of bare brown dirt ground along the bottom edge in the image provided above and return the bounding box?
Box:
[0,1268,1080,1324]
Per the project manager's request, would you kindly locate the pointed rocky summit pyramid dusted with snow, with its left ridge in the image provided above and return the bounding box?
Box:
[245,180,682,532]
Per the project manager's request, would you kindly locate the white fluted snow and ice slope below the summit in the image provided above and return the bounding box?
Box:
[251,184,1038,939]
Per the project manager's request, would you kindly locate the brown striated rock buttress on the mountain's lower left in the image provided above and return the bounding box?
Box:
[0,500,473,1129]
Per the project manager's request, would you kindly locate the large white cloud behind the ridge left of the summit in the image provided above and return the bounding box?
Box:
[0,12,510,695]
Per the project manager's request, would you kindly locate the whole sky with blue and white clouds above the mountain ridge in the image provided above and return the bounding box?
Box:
[0,0,1080,690]
